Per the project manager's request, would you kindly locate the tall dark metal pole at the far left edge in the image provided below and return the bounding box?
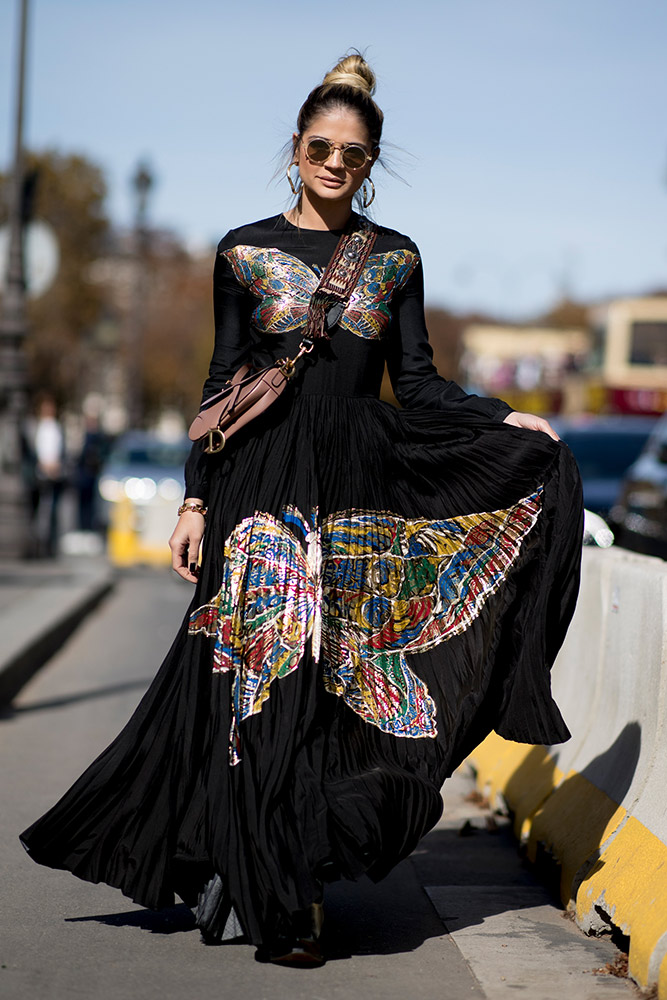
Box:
[0,0,30,559]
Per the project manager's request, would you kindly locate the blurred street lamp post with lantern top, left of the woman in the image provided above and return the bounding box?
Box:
[128,164,153,427]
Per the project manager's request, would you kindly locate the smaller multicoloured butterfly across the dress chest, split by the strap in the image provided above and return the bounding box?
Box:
[223,245,419,340]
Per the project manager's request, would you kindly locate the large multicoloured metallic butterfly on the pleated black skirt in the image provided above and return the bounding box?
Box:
[189,487,542,764]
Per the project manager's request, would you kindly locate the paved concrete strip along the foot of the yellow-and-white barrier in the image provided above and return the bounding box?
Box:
[422,764,641,1000]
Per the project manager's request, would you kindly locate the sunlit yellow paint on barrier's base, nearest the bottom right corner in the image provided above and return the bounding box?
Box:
[576,816,667,998]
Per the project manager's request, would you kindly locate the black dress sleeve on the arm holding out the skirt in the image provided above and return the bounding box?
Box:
[386,256,512,421]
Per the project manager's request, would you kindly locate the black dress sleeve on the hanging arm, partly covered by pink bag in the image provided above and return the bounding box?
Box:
[185,230,250,503]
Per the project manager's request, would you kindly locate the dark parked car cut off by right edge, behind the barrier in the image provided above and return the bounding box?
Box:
[611,414,667,559]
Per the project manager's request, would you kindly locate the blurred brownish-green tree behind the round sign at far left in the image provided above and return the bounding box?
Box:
[0,150,108,405]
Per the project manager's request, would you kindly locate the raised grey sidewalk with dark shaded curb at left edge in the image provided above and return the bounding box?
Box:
[0,557,113,705]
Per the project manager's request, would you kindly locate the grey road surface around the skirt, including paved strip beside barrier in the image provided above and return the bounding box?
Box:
[0,571,634,1000]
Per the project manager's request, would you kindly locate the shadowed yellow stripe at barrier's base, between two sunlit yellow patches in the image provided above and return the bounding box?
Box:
[527,771,626,906]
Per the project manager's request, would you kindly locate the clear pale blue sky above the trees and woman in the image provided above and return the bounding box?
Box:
[0,0,667,318]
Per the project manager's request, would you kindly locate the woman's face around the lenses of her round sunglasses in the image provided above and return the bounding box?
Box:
[294,109,377,201]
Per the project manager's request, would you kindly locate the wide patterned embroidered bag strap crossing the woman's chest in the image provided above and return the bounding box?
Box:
[306,217,377,340]
